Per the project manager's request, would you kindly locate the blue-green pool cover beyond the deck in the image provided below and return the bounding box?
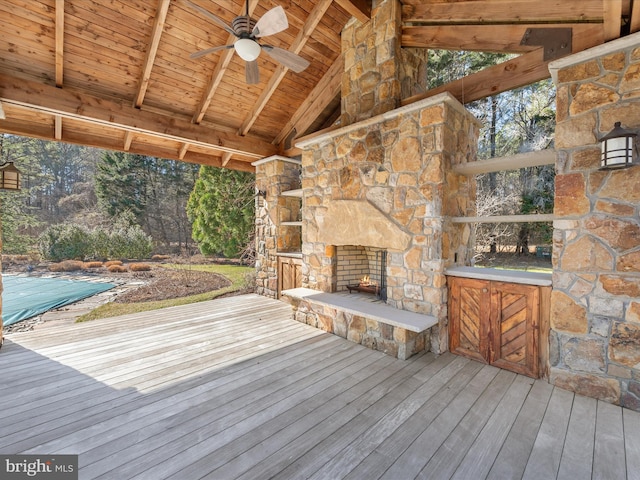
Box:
[2,275,115,325]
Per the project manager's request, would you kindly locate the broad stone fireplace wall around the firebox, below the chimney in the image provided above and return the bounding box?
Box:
[298,93,478,352]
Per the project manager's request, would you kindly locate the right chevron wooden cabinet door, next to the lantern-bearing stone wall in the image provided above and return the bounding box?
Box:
[489,282,540,378]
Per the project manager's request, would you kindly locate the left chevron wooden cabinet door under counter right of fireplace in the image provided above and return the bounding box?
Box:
[448,277,491,363]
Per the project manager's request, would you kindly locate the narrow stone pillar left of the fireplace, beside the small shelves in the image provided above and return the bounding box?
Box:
[253,156,301,298]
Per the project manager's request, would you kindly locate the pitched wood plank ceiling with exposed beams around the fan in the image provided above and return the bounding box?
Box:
[0,0,640,171]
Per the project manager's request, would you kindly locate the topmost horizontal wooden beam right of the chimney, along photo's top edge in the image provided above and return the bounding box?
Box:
[402,0,608,24]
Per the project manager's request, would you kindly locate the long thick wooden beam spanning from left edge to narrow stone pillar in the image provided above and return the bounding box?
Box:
[0,74,278,159]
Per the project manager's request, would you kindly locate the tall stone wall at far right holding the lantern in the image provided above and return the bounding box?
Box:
[550,34,640,410]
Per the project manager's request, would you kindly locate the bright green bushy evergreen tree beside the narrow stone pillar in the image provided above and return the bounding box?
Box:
[187,166,255,257]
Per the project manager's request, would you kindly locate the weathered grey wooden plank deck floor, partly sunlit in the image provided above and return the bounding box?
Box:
[0,295,640,480]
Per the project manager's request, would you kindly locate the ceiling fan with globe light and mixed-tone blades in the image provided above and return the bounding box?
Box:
[186,0,309,84]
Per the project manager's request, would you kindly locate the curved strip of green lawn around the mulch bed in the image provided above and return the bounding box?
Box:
[76,264,254,322]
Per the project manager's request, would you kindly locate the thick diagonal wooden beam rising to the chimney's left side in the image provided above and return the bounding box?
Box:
[273,55,344,146]
